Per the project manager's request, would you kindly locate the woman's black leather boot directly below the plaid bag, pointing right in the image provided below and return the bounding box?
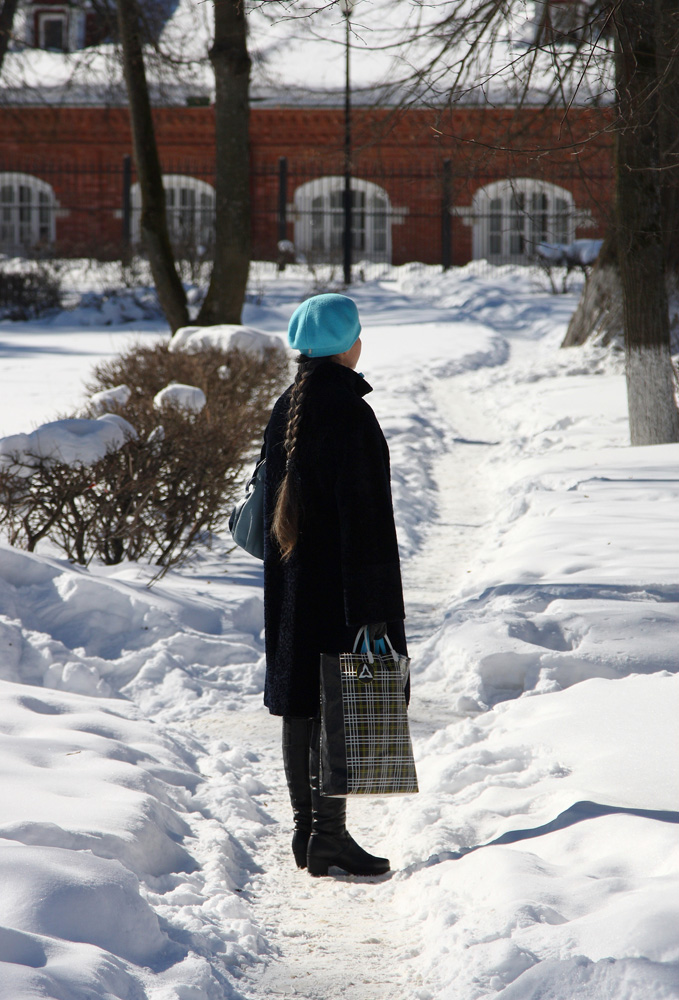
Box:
[307,720,389,875]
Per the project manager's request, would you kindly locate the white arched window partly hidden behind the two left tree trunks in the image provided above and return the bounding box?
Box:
[131,174,215,250]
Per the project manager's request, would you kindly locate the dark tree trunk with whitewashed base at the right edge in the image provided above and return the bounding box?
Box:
[616,0,679,445]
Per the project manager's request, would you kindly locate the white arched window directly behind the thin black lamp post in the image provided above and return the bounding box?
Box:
[295,176,392,262]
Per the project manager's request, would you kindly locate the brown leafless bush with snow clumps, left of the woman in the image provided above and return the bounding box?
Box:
[0,341,289,567]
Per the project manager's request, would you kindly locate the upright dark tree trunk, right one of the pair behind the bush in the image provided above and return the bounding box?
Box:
[198,0,251,326]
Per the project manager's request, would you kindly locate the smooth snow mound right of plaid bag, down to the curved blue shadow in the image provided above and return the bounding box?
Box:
[394,674,679,864]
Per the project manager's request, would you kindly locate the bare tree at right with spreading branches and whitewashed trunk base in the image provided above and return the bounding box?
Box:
[350,0,679,444]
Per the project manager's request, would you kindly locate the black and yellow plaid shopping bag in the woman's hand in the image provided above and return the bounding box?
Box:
[321,630,418,795]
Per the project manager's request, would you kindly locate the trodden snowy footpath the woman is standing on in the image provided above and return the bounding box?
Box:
[170,356,508,1000]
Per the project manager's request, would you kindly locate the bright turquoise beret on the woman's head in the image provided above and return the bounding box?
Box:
[288,293,361,358]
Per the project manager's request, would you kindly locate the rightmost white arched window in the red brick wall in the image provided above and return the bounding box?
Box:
[471,177,575,262]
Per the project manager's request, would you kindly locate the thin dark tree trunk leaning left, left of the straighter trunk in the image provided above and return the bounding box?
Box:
[117,0,189,332]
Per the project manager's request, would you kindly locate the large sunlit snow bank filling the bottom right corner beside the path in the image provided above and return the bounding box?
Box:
[392,675,679,1000]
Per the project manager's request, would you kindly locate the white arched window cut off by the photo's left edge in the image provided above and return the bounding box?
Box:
[0,173,56,253]
